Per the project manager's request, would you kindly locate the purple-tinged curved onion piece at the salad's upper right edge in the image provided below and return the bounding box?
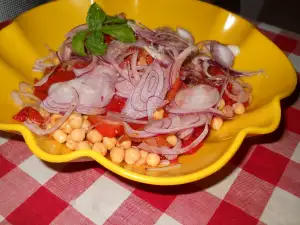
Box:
[211,42,234,68]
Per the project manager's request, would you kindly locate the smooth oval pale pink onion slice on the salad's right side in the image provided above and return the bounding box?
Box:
[175,84,220,110]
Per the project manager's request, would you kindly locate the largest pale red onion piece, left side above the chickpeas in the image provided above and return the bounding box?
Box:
[42,65,117,114]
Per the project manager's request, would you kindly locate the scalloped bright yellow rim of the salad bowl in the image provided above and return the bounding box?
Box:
[0,2,296,185]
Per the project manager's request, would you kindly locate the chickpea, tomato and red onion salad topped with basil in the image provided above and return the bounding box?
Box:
[11,3,261,169]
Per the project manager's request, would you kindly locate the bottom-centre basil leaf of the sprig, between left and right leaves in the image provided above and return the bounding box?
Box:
[85,31,107,55]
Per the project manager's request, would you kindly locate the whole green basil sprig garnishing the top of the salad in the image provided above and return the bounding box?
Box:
[72,3,136,56]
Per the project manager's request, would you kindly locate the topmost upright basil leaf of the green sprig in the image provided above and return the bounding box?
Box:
[86,3,106,30]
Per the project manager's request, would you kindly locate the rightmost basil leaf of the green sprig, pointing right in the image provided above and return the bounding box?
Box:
[101,24,136,43]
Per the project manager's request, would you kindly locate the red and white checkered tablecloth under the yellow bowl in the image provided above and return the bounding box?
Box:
[0,24,300,225]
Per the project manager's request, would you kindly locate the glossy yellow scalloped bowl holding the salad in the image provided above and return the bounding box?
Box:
[0,0,297,185]
